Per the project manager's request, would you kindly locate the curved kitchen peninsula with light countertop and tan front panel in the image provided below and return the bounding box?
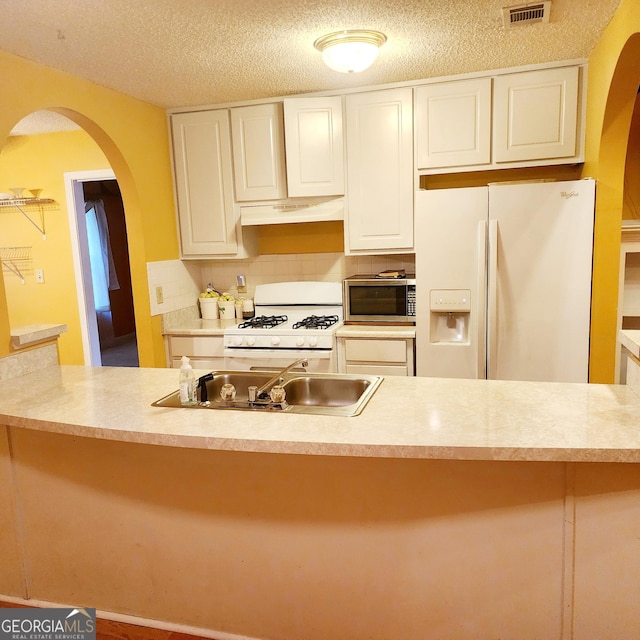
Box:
[0,366,640,640]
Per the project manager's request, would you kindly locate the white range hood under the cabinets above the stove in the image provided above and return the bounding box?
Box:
[240,197,344,227]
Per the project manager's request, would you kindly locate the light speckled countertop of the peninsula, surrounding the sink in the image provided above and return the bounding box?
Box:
[0,366,640,462]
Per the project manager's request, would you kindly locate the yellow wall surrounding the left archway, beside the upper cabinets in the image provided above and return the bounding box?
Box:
[0,51,178,366]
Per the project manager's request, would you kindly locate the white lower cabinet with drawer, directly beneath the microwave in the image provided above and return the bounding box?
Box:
[338,337,415,376]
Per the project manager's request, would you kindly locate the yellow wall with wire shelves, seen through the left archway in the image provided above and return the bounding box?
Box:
[0,130,109,364]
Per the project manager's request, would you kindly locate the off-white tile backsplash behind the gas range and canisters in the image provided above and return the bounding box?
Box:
[147,253,415,315]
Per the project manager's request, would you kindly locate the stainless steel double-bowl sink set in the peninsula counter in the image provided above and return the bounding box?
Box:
[152,371,383,417]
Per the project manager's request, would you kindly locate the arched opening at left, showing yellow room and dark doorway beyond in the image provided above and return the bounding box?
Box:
[3,112,138,366]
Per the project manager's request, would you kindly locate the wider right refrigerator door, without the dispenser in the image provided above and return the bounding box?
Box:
[490,180,595,382]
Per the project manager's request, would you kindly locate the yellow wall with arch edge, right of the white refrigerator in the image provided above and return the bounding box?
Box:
[583,0,640,382]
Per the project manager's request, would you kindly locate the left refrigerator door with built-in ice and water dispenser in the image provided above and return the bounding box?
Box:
[415,187,488,378]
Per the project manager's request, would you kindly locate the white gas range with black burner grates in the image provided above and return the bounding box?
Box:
[224,281,343,373]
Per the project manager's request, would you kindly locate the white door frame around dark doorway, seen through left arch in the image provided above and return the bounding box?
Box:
[64,169,116,367]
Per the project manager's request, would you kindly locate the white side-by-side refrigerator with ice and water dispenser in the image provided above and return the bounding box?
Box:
[415,179,595,382]
